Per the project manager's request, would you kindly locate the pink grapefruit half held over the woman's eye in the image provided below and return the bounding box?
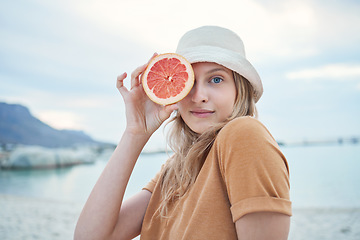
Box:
[142,53,195,105]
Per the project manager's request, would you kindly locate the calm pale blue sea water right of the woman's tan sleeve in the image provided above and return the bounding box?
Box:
[282,144,360,208]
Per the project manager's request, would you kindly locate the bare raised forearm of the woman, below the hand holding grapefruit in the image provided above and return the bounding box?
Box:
[75,131,149,239]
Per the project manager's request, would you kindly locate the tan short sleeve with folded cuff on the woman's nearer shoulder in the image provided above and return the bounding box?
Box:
[214,117,291,222]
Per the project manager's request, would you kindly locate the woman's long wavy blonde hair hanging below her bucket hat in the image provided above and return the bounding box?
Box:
[158,72,257,217]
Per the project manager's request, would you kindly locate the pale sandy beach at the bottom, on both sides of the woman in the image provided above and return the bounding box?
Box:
[0,195,360,240]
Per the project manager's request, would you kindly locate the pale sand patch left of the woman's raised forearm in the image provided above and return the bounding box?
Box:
[0,195,82,240]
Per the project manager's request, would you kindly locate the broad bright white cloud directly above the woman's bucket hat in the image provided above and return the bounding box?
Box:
[43,0,318,61]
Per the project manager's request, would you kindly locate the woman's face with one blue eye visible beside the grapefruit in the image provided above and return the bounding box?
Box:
[178,62,236,134]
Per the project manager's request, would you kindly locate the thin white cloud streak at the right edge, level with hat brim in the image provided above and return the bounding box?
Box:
[285,63,360,81]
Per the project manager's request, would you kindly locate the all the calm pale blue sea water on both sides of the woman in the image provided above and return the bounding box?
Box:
[0,144,360,208]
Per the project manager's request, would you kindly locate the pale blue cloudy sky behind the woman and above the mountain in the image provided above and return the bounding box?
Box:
[0,0,360,149]
